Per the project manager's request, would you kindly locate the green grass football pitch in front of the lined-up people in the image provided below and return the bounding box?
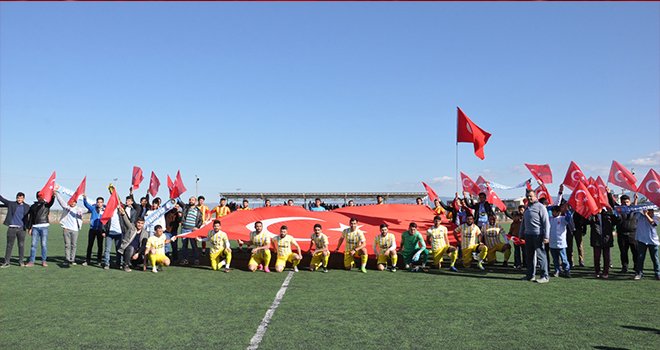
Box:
[0,225,660,349]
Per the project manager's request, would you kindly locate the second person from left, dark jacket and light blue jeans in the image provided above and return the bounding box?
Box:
[25,189,55,267]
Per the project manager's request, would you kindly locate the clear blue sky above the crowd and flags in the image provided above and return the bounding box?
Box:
[0,2,660,199]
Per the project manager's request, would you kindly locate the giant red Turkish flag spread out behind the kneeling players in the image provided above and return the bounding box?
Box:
[173,204,456,254]
